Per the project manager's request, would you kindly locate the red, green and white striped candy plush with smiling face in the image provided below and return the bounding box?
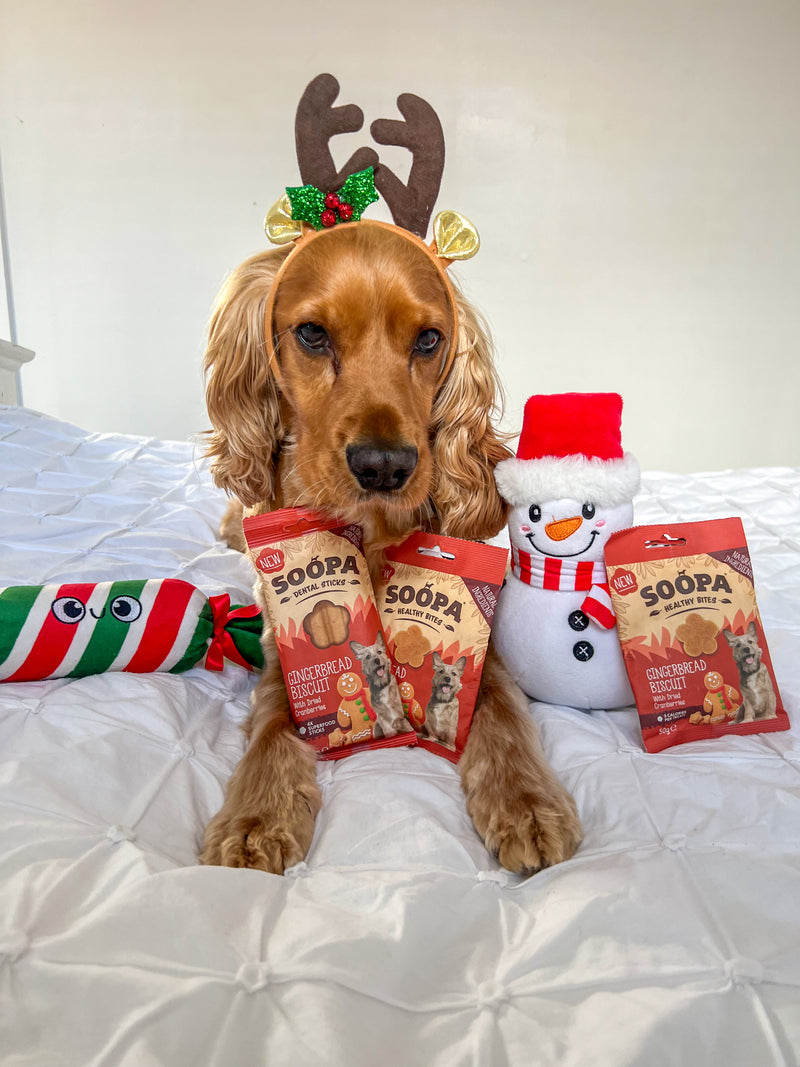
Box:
[0,578,263,682]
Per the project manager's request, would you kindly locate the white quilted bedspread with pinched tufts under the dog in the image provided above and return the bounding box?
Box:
[0,409,800,1067]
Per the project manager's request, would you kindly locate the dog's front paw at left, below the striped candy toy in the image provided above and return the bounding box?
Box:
[201,808,314,874]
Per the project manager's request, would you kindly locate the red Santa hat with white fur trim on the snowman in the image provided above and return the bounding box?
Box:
[495,393,640,508]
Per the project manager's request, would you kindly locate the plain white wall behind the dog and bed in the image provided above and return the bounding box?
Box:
[0,0,800,471]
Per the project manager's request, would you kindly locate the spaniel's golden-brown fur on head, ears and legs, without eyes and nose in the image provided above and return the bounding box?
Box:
[202,222,580,873]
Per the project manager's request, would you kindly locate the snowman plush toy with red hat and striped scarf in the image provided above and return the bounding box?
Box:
[492,393,640,711]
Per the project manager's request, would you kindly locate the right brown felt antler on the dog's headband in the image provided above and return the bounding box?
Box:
[367,93,445,238]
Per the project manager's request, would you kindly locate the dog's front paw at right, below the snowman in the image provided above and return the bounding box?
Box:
[469,790,582,874]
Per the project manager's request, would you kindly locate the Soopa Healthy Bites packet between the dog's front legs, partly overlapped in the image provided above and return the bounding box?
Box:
[375,532,508,763]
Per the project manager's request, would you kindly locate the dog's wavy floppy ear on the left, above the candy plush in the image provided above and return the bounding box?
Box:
[204,249,289,507]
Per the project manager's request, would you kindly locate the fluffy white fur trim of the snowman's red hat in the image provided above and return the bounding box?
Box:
[495,452,641,508]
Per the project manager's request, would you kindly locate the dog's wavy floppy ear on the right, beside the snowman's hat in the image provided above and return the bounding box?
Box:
[431,291,511,541]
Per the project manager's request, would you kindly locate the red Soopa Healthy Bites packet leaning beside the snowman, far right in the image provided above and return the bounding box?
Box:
[606,519,789,752]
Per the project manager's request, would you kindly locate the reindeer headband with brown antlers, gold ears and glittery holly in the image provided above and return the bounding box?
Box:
[265,74,480,379]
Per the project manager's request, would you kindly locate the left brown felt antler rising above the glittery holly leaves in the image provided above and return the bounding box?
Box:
[294,74,378,192]
